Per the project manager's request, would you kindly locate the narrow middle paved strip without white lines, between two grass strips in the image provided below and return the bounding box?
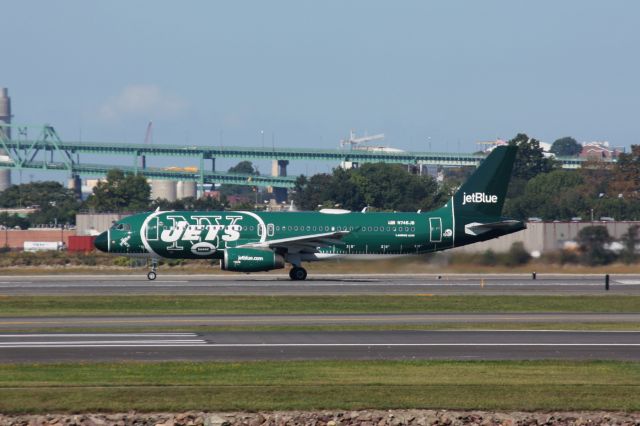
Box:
[0,313,640,332]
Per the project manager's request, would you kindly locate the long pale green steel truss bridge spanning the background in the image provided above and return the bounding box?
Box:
[0,123,596,188]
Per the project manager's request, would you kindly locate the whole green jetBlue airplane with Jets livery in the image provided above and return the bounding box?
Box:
[94,146,526,281]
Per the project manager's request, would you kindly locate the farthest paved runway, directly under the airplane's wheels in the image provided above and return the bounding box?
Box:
[0,272,640,296]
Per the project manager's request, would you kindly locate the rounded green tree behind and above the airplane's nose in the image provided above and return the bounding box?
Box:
[86,169,151,212]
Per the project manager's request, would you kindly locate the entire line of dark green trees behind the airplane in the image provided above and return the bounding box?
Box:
[0,134,640,231]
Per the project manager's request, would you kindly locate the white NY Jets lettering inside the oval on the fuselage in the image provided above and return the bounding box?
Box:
[160,215,243,251]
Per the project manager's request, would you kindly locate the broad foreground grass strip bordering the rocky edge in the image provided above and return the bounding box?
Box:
[0,361,640,413]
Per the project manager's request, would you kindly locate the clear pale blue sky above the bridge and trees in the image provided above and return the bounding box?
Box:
[0,0,640,176]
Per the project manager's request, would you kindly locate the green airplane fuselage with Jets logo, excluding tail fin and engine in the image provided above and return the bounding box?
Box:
[96,206,460,259]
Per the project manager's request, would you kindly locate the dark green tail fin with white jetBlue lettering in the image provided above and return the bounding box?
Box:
[453,146,518,217]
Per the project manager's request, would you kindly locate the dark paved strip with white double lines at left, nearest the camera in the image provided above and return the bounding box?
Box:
[0,330,640,363]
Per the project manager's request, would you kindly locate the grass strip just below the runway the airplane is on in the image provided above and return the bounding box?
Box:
[0,295,640,316]
